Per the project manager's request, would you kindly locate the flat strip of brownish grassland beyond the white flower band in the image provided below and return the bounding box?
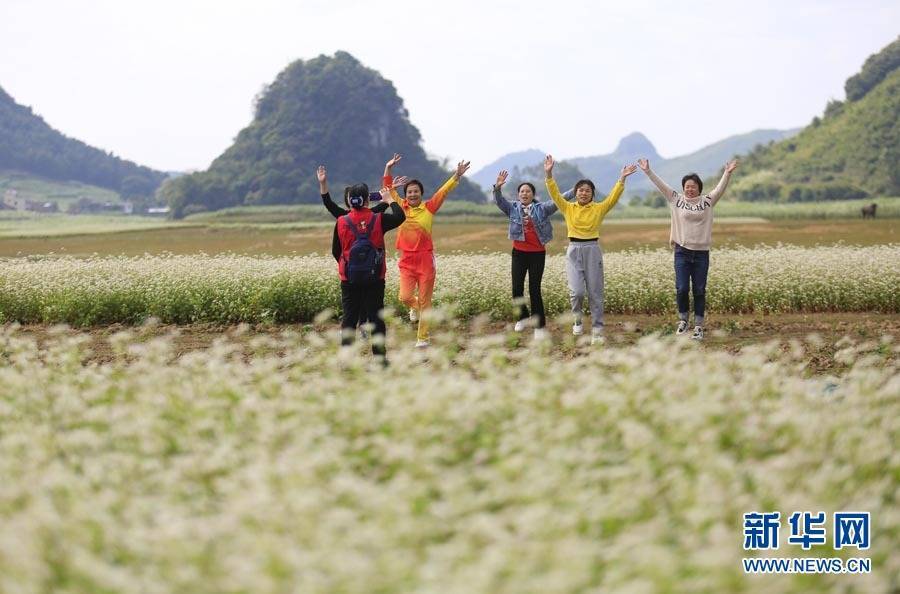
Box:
[0,213,888,257]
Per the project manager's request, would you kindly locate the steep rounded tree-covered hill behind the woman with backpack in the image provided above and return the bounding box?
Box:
[160,52,485,217]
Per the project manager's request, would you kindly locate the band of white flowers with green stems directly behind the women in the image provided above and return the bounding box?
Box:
[0,245,900,326]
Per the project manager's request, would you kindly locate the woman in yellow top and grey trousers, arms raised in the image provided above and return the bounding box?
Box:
[544,155,637,344]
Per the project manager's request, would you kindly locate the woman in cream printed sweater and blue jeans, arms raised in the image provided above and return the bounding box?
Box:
[638,159,738,340]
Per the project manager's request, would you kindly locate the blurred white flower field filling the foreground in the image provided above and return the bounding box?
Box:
[0,326,900,594]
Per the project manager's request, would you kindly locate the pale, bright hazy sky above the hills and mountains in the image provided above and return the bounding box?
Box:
[0,0,900,171]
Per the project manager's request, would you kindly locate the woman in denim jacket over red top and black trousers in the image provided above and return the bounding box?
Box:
[494,170,557,340]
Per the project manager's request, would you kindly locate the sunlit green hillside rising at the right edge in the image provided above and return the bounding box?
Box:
[731,38,900,202]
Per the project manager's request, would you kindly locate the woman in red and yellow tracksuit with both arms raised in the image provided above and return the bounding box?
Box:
[383,155,469,347]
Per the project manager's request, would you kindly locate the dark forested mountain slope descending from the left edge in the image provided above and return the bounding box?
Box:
[0,88,167,197]
